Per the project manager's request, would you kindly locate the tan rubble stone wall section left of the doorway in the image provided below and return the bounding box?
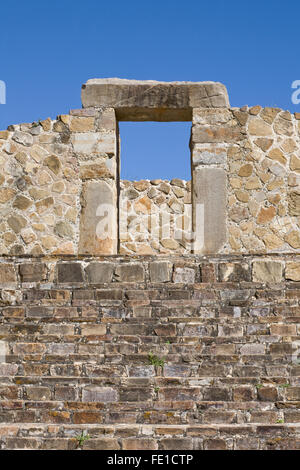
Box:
[0,109,117,255]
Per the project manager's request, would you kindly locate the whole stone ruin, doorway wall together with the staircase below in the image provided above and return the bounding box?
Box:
[0,79,300,450]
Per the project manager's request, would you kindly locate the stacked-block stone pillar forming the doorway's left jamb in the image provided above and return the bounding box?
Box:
[76,108,118,255]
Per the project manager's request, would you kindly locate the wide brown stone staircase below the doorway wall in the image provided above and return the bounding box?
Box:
[0,254,300,450]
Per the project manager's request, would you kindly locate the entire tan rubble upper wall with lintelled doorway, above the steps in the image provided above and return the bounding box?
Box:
[0,80,300,255]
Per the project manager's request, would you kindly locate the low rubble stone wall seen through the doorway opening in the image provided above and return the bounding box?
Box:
[120,178,193,255]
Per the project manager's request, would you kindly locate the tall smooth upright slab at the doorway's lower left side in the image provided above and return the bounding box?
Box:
[78,181,118,255]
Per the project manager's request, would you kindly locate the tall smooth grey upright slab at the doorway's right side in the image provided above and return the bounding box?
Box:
[192,168,226,253]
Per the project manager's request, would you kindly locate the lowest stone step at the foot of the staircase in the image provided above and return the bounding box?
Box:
[0,423,300,450]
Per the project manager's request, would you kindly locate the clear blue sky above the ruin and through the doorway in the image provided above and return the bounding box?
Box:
[0,0,300,178]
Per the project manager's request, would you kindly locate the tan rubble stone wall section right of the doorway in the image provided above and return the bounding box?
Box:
[191,106,300,253]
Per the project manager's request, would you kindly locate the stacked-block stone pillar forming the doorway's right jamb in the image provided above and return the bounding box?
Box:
[190,108,232,254]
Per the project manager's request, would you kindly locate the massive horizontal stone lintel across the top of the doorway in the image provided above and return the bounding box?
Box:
[81,78,229,117]
